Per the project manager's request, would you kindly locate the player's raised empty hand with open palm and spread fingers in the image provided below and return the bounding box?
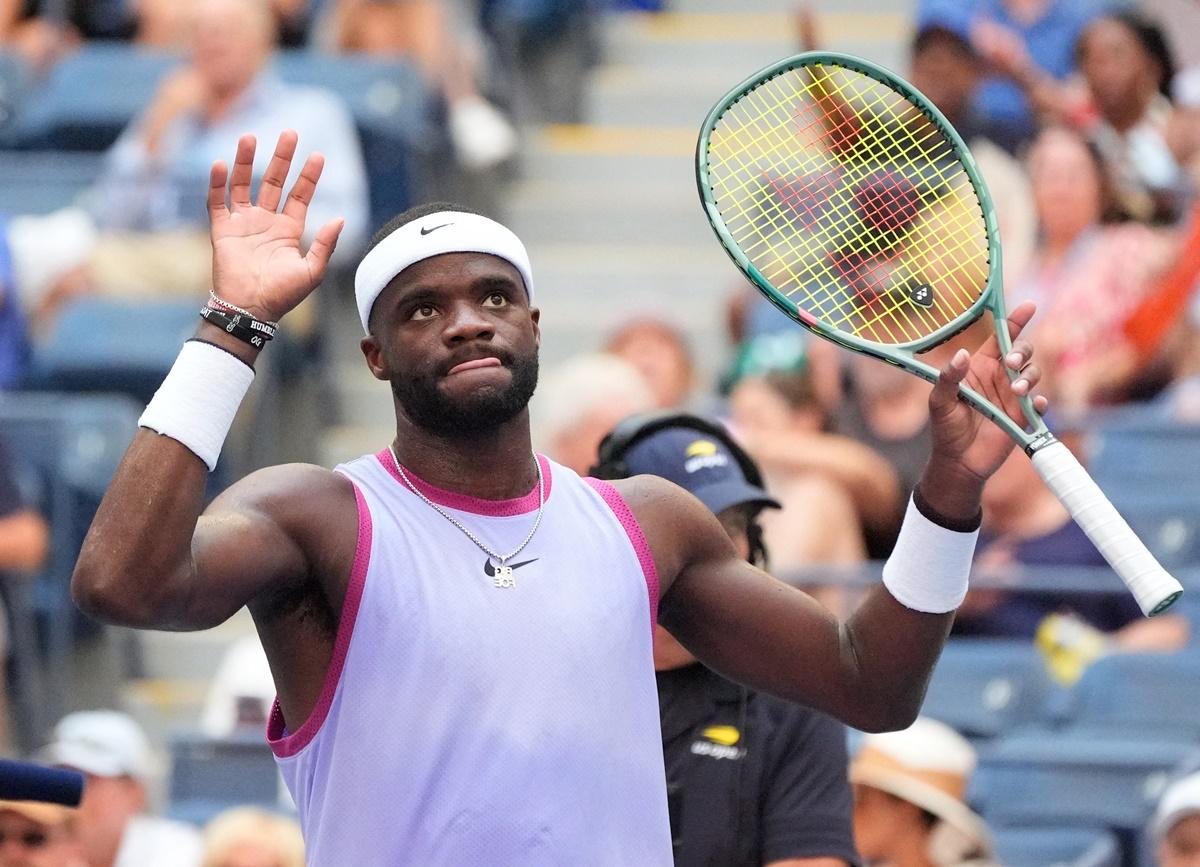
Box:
[209,130,344,322]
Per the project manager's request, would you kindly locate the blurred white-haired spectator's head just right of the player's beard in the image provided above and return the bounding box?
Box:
[532,353,658,476]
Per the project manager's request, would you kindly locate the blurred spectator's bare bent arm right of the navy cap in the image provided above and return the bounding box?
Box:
[746,432,904,540]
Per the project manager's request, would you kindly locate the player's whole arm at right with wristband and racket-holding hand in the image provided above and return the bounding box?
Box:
[643,304,1045,731]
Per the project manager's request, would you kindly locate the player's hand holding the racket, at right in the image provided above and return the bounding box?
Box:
[929,303,1046,499]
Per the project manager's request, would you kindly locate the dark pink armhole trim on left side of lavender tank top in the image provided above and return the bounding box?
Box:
[266,482,371,759]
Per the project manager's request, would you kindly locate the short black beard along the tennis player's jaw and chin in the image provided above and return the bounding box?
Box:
[391,353,538,440]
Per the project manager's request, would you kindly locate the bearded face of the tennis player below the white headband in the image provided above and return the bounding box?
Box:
[362,253,541,436]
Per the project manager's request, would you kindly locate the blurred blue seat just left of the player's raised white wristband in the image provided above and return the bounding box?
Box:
[29,298,200,403]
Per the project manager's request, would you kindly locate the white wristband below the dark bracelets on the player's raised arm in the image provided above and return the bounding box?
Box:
[138,340,254,472]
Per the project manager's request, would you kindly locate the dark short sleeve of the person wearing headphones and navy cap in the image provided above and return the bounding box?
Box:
[760,707,856,867]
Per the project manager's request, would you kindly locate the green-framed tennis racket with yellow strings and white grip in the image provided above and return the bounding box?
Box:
[696,52,1183,616]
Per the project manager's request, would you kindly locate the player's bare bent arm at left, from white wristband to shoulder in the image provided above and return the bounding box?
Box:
[71,417,355,629]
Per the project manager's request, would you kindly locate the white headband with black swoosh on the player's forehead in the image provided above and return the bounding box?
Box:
[354,210,533,334]
